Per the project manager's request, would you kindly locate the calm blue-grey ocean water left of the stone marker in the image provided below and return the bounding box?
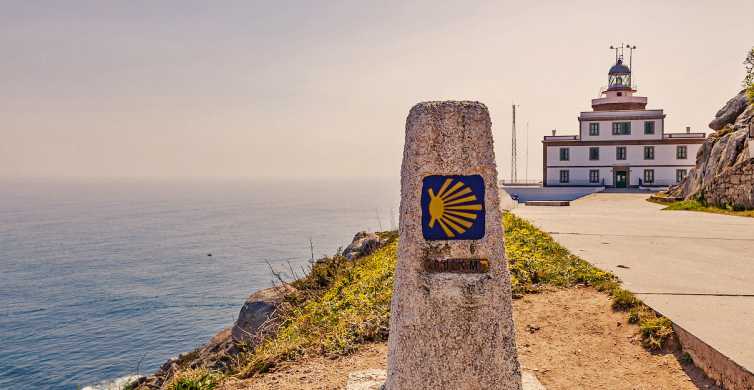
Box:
[0,178,399,390]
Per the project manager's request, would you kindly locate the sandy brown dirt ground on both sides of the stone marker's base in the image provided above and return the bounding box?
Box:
[219,288,718,390]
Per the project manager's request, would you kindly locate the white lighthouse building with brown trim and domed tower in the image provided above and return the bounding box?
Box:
[542,55,705,187]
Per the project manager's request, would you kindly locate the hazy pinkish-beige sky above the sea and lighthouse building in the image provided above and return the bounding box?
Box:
[0,0,754,178]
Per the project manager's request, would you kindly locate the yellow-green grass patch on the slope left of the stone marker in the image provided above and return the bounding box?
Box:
[240,238,397,377]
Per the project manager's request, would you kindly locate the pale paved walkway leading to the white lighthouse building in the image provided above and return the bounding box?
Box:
[514,194,754,372]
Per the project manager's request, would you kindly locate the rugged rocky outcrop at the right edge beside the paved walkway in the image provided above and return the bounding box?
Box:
[667,90,754,209]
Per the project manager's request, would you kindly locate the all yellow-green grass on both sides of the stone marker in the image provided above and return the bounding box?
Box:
[162,213,672,384]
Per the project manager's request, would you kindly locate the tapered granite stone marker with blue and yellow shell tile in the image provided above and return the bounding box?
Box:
[385,101,521,390]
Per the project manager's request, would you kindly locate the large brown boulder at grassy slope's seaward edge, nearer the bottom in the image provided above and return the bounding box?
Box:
[231,284,296,345]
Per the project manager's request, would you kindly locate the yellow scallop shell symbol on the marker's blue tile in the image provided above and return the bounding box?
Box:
[428,178,482,238]
